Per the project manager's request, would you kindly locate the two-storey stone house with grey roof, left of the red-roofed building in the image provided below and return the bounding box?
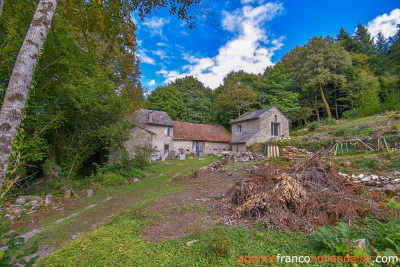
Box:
[124,109,174,159]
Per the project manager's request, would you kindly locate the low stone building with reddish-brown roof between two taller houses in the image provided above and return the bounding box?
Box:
[172,121,232,156]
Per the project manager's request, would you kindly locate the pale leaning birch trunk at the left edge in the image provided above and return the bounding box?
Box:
[0,0,58,192]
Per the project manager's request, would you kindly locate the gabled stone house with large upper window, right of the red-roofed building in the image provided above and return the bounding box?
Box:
[230,106,290,151]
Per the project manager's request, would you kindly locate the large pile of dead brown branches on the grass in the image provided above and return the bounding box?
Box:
[229,152,391,231]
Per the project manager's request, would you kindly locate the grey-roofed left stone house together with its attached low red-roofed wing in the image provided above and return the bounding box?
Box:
[124,109,232,159]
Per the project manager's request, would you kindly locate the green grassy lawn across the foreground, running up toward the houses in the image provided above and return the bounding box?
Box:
[37,157,344,266]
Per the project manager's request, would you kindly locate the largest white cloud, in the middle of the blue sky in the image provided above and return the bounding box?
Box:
[157,1,284,88]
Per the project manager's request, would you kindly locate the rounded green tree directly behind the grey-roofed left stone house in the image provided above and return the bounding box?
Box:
[147,84,187,121]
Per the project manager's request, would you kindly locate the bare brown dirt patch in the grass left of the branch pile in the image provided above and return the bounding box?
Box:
[142,168,246,242]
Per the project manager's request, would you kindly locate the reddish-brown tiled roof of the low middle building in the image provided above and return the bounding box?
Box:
[173,121,232,143]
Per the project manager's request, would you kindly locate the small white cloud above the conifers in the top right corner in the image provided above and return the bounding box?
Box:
[368,8,400,38]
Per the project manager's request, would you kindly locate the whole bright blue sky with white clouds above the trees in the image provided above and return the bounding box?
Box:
[135,0,400,91]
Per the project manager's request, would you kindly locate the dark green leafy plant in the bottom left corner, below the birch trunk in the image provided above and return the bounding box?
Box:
[0,211,39,266]
